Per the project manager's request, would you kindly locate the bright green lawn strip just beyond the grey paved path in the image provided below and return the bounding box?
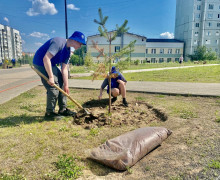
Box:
[71,66,220,83]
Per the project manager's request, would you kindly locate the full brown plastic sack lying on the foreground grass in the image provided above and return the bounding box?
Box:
[88,127,171,170]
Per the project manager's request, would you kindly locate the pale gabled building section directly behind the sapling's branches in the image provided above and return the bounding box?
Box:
[86,32,147,63]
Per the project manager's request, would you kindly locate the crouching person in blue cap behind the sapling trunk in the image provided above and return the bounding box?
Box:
[98,66,128,107]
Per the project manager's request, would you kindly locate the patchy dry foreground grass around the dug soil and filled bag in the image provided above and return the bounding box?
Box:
[0,86,220,180]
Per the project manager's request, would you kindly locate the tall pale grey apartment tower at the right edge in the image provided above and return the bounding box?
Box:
[175,0,220,59]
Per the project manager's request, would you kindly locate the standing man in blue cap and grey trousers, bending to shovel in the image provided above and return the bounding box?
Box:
[33,31,86,120]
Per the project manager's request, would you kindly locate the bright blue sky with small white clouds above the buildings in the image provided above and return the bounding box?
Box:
[0,0,176,52]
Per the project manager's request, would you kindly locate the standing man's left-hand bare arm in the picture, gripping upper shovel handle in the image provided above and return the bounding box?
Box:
[43,52,54,86]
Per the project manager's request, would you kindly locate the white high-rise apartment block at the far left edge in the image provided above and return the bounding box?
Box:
[0,24,22,62]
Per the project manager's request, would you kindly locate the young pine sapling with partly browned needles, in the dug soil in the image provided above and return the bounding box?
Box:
[93,8,136,113]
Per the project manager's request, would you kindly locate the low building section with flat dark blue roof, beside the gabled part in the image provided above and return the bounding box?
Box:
[146,38,184,63]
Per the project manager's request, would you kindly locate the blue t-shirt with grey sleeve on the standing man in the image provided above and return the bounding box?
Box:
[33,37,70,66]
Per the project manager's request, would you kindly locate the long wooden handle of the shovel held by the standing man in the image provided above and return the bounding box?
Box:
[31,66,91,115]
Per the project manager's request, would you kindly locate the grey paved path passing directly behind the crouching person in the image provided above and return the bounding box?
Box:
[69,79,220,97]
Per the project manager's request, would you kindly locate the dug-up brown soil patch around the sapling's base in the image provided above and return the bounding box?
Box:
[73,99,167,129]
